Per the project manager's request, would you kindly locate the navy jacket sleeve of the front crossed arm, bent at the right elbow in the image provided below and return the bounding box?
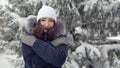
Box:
[32,39,67,67]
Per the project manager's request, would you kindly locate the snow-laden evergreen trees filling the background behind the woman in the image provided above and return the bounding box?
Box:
[0,0,120,68]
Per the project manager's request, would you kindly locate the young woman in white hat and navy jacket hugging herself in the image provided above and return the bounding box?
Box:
[22,6,68,68]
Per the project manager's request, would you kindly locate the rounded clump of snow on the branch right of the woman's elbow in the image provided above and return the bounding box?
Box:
[75,43,101,59]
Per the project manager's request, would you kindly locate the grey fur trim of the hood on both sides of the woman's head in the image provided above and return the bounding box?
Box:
[23,15,66,37]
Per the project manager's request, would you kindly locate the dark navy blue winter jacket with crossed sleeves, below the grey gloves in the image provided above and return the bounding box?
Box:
[22,39,68,68]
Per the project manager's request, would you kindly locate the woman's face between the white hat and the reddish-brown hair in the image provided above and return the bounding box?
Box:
[40,17,54,28]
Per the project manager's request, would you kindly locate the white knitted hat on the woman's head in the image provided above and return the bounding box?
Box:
[37,5,57,22]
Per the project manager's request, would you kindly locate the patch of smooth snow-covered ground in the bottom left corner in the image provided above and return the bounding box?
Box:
[0,53,14,68]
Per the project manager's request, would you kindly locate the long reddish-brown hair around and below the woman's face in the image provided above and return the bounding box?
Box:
[33,21,56,41]
